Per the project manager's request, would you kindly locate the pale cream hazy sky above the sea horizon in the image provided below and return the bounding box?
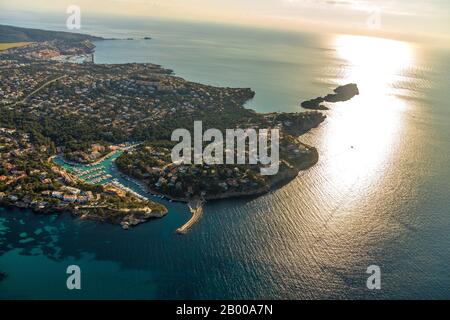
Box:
[0,0,450,41]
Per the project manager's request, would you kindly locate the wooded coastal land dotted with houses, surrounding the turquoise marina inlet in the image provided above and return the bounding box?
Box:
[0,26,325,233]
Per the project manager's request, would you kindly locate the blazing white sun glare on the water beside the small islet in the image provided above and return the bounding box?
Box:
[324,36,414,197]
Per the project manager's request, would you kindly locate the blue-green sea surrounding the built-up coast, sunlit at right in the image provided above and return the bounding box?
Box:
[0,14,450,299]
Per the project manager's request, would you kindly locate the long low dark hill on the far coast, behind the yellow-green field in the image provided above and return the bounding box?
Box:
[0,25,104,43]
